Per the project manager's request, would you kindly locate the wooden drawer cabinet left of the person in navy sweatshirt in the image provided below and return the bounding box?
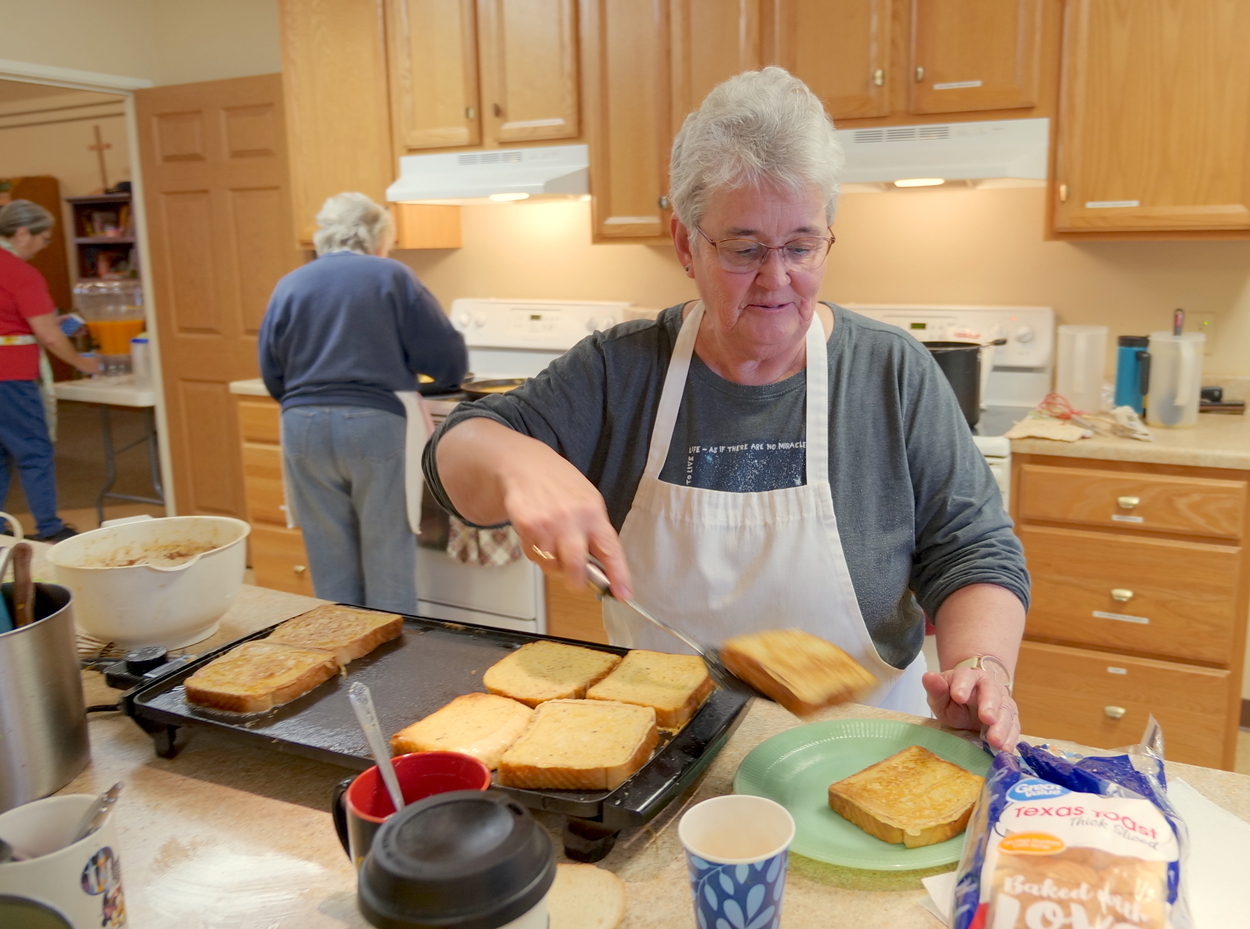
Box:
[235,395,314,596]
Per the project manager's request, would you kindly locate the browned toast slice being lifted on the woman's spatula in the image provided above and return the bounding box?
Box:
[720,629,876,716]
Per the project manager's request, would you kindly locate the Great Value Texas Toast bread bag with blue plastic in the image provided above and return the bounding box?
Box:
[950,719,1194,929]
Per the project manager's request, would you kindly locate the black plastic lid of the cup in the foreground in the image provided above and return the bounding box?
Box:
[356,790,555,929]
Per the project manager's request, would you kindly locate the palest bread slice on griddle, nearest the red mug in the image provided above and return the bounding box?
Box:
[391,694,534,770]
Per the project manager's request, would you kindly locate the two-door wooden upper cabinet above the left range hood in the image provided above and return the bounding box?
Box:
[386,0,581,154]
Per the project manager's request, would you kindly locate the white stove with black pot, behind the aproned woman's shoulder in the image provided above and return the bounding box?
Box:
[844,304,1055,506]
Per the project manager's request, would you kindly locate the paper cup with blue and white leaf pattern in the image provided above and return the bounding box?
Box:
[678,794,794,929]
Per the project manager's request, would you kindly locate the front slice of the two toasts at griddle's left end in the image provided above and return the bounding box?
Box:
[185,639,339,713]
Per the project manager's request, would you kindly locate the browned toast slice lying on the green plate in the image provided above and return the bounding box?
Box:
[829,745,985,848]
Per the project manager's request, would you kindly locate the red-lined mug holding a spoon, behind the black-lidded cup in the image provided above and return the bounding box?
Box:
[330,751,490,868]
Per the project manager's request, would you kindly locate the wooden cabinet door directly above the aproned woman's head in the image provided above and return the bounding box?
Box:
[764,0,890,120]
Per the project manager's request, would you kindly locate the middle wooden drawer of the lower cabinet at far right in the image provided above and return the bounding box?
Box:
[1016,525,1241,665]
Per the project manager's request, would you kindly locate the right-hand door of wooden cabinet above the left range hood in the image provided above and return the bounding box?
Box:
[478,0,581,145]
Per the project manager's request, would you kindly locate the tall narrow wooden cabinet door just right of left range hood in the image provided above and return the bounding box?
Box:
[581,0,673,243]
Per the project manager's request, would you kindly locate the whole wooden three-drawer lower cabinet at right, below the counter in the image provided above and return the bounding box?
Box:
[1011,455,1250,769]
